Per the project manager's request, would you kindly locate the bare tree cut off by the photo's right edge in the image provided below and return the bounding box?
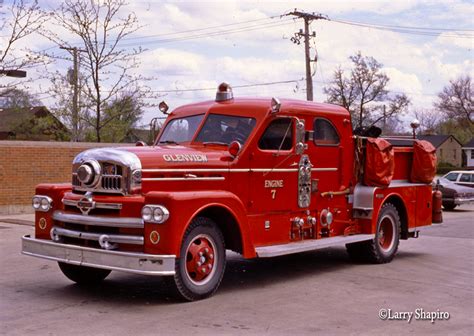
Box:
[434,75,474,125]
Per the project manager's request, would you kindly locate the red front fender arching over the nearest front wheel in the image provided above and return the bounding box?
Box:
[144,190,255,257]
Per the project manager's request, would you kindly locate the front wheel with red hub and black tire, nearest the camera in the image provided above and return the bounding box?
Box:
[172,217,226,301]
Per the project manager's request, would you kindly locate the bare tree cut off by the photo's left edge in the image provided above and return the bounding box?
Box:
[0,0,47,94]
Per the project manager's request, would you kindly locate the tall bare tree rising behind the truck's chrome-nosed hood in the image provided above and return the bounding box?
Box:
[46,0,154,142]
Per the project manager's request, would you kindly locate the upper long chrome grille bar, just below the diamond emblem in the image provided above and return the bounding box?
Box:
[53,210,144,229]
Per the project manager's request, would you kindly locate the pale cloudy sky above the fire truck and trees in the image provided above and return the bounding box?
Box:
[0,0,474,129]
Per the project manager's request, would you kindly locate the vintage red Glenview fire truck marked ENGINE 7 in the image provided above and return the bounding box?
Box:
[22,84,440,301]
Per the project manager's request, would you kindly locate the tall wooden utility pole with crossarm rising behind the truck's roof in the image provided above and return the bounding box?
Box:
[286,9,329,101]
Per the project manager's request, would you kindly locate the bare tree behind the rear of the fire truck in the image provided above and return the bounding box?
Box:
[324,52,410,128]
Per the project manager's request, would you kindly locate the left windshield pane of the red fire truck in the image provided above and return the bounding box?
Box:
[158,114,204,143]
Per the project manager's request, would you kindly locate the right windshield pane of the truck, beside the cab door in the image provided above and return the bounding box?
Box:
[196,114,256,145]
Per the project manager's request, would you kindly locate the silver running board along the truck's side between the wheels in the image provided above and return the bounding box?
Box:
[255,234,375,258]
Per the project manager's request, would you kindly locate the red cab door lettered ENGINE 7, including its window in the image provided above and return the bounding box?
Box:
[248,116,299,246]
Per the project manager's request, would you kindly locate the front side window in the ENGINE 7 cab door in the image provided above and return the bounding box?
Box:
[258,118,293,150]
